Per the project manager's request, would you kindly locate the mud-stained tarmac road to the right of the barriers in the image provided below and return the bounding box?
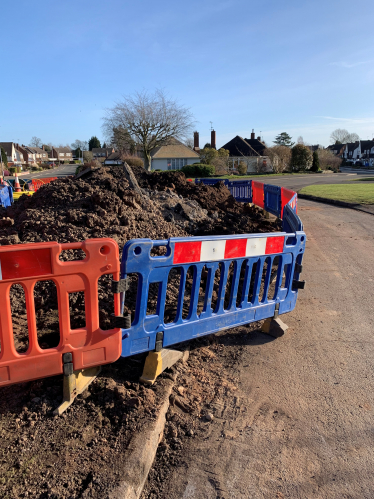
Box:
[153,200,374,499]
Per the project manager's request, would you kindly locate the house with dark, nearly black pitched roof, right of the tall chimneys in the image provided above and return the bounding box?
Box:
[222,130,271,172]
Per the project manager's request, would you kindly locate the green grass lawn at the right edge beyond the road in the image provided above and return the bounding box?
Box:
[299,184,374,204]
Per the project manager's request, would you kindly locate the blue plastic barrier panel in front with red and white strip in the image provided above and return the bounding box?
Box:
[121,232,305,357]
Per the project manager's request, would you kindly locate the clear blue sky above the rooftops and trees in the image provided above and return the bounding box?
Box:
[0,0,374,146]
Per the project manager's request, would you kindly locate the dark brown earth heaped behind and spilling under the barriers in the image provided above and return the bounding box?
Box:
[0,168,280,498]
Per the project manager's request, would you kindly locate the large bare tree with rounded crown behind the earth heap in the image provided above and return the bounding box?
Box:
[103,90,193,170]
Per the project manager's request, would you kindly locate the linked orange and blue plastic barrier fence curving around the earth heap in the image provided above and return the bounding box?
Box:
[0,181,306,386]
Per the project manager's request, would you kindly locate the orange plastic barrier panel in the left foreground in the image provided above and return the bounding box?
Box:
[0,239,121,386]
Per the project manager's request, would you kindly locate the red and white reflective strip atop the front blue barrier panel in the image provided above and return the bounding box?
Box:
[173,236,284,264]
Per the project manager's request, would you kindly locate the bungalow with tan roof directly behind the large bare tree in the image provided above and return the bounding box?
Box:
[151,137,200,170]
